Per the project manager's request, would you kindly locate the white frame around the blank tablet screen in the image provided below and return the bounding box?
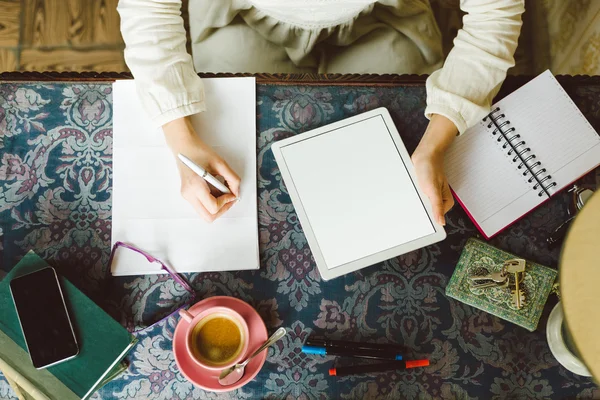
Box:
[271,107,446,281]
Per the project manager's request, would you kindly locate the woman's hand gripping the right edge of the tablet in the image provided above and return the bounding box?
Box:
[411,115,458,225]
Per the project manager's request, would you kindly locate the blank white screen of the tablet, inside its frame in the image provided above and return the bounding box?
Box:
[281,115,435,269]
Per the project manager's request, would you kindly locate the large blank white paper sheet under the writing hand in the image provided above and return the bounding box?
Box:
[112,78,259,275]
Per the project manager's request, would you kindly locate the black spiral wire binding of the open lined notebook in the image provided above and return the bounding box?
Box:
[483,107,556,197]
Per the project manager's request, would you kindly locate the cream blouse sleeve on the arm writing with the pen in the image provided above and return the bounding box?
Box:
[117,0,205,126]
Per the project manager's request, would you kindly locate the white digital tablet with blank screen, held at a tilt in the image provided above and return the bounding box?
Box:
[271,108,446,280]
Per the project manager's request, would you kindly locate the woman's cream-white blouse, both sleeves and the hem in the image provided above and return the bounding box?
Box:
[118,0,524,133]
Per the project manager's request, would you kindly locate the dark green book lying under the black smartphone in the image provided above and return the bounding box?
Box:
[0,251,137,400]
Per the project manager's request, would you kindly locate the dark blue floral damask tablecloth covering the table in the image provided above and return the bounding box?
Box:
[0,83,600,400]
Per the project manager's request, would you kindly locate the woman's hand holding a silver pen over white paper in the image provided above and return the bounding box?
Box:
[163,117,240,222]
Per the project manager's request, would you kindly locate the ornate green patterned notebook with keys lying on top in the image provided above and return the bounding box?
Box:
[446,238,558,332]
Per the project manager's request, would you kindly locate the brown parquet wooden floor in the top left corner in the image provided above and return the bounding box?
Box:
[0,0,187,72]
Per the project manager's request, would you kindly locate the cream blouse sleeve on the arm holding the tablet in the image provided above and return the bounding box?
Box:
[425,0,525,133]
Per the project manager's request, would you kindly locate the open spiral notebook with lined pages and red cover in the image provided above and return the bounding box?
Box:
[445,71,600,238]
